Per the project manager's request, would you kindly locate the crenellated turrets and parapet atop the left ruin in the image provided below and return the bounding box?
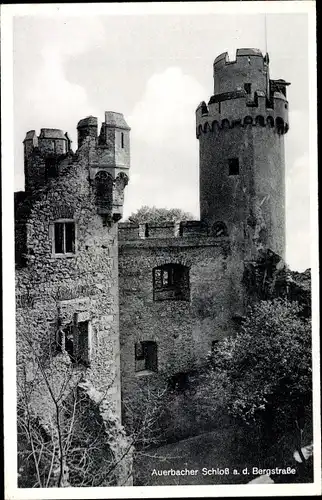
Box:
[24,111,130,222]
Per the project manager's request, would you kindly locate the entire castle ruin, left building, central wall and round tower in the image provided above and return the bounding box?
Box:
[15,49,289,454]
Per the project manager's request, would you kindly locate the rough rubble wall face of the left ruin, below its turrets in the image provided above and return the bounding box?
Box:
[16,139,120,411]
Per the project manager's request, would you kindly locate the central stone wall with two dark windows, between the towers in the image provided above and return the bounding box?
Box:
[119,224,244,425]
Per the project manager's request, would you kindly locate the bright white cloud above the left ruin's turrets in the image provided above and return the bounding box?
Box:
[14,18,105,189]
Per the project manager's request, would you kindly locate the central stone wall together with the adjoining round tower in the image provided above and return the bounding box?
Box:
[119,49,289,428]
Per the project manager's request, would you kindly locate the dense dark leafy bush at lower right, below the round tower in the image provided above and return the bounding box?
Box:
[196,299,312,458]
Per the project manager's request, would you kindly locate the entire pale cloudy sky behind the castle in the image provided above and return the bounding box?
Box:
[13,2,314,271]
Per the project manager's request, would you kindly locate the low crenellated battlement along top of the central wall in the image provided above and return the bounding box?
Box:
[118,221,228,241]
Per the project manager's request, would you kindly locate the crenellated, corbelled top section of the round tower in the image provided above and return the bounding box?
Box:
[196,49,289,137]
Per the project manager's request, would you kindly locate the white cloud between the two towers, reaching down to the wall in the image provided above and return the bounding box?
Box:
[124,67,208,216]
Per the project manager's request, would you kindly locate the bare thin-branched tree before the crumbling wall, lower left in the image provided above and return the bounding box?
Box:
[17,332,133,488]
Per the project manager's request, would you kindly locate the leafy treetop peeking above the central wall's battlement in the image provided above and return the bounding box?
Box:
[128,205,194,224]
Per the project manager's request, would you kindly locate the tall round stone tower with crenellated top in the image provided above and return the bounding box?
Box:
[196,49,289,257]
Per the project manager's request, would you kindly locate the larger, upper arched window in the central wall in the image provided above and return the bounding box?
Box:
[153,264,190,301]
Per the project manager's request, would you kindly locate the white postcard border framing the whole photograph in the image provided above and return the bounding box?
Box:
[1,0,321,500]
